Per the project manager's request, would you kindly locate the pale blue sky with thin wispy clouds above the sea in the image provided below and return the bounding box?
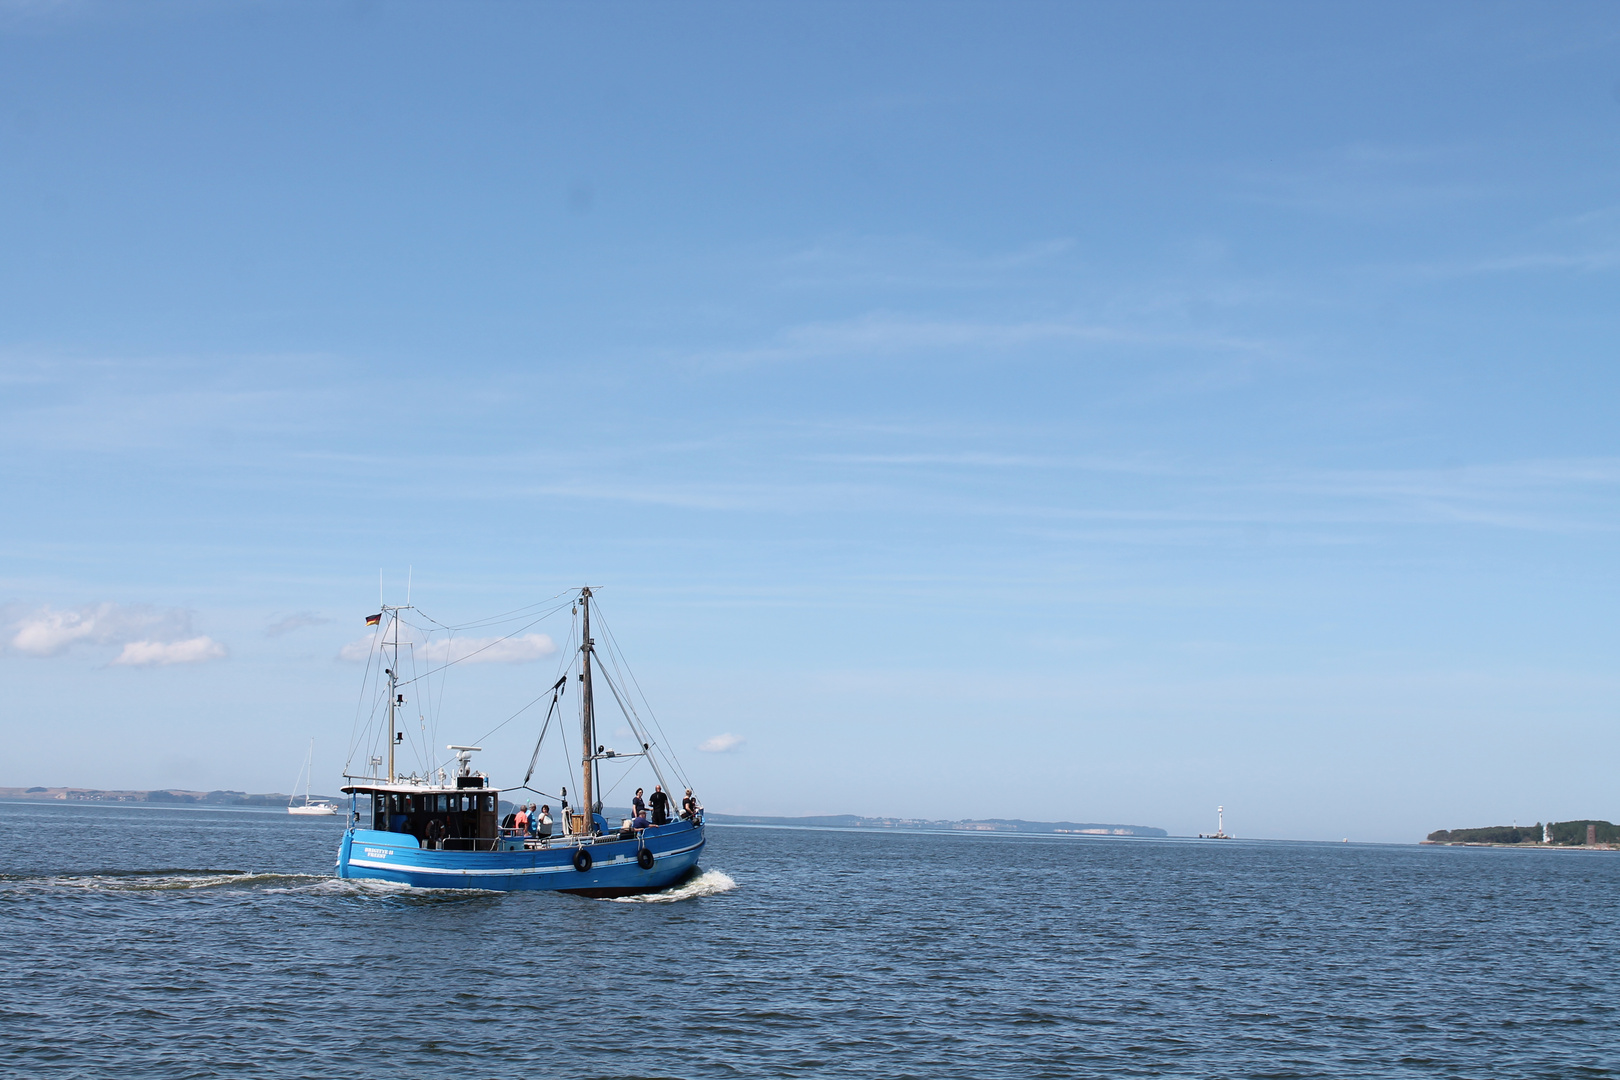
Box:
[0,0,1620,842]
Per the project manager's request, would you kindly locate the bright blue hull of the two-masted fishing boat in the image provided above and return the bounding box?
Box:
[337,821,703,897]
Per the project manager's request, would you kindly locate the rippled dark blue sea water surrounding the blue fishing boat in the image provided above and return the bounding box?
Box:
[0,803,1620,1078]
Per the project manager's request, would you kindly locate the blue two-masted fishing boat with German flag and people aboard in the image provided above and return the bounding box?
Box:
[337,588,703,897]
